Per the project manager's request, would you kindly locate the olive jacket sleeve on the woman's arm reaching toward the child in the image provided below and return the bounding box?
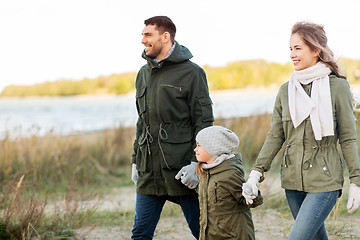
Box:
[252,85,287,176]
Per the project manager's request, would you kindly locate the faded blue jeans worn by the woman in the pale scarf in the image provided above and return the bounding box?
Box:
[285,190,340,240]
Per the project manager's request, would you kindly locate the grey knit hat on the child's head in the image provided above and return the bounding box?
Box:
[196,126,240,158]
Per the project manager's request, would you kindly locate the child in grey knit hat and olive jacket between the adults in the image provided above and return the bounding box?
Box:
[183,126,262,240]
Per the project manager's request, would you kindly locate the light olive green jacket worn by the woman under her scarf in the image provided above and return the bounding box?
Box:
[253,75,360,193]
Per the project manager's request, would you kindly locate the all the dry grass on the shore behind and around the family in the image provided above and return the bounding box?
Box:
[0,114,360,239]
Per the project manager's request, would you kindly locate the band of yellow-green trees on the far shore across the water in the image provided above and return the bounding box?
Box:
[0,59,360,97]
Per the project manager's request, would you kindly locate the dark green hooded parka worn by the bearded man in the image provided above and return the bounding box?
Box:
[131,42,214,196]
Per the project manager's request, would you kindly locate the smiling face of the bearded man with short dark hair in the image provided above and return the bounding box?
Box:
[141,25,163,59]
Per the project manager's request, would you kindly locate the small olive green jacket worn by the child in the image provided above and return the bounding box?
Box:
[197,154,263,240]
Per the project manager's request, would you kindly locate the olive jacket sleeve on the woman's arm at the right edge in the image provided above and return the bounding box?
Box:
[335,80,360,186]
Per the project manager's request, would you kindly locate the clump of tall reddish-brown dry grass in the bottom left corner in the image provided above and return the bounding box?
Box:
[0,175,95,240]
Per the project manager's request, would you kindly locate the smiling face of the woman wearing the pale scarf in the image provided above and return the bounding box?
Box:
[290,33,319,71]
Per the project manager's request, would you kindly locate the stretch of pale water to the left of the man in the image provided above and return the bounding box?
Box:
[0,95,136,137]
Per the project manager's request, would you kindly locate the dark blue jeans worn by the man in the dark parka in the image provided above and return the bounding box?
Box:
[131,194,200,240]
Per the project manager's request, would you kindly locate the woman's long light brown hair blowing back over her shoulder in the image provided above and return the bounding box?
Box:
[291,21,345,78]
